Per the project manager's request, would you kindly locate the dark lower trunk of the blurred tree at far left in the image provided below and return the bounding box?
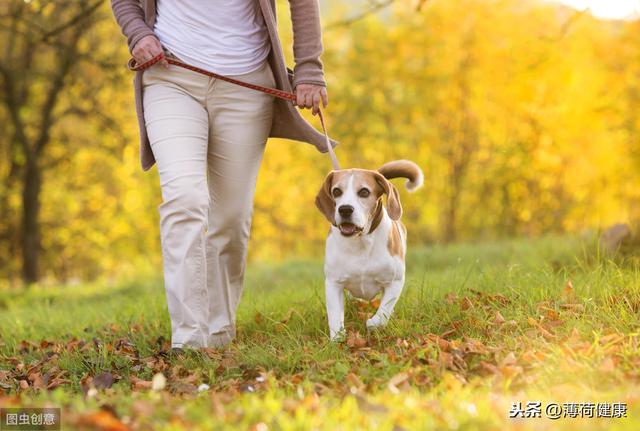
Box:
[20,160,42,285]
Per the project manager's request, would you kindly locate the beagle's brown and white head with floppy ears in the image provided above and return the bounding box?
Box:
[316,169,402,236]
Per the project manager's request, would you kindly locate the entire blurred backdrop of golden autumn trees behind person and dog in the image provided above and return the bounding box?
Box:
[0,0,640,284]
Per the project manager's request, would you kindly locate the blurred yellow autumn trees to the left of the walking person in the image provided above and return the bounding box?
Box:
[0,0,155,283]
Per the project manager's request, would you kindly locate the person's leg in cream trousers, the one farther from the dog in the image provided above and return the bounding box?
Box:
[143,65,209,347]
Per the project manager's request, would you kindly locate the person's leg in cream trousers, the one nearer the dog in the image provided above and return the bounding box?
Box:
[207,62,274,347]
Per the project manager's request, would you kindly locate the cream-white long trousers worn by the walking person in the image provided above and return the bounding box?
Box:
[142,58,275,347]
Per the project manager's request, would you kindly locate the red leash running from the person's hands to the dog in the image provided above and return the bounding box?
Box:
[127,52,340,170]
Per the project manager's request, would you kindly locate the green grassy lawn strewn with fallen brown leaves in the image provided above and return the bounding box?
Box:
[0,237,640,430]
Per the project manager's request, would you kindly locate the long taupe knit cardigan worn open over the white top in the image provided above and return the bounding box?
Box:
[111,0,337,171]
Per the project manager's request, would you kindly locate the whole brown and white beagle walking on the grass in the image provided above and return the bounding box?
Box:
[315,160,424,340]
